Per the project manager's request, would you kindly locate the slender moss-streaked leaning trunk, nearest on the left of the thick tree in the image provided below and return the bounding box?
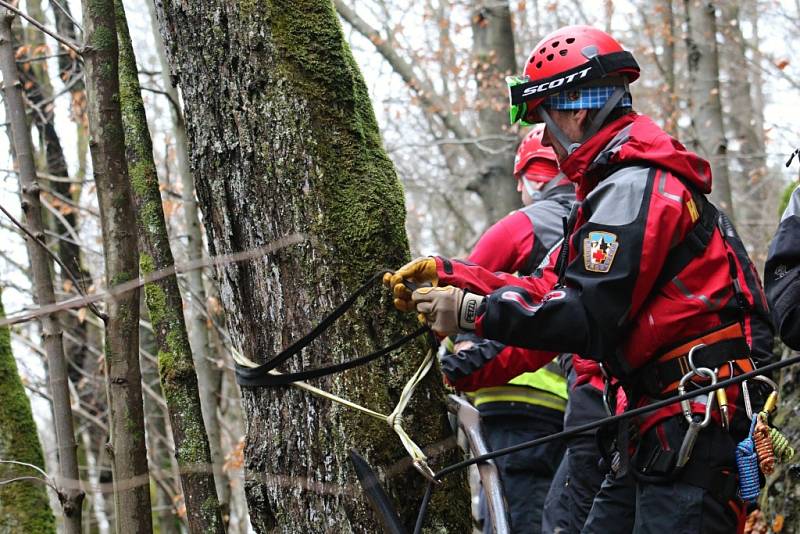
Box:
[114,0,224,532]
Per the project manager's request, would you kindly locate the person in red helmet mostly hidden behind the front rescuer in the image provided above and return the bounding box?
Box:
[441,128,575,534]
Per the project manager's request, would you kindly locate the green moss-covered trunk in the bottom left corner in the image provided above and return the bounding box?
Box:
[0,292,56,534]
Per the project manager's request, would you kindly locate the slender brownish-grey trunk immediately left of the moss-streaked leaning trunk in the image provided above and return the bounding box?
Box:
[82,0,152,533]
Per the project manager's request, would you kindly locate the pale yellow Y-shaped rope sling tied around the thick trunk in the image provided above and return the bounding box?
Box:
[231,349,433,478]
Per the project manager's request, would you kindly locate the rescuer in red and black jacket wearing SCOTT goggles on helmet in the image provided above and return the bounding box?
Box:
[385,26,772,534]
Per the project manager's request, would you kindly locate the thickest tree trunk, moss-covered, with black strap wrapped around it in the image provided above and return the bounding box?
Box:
[156,0,469,532]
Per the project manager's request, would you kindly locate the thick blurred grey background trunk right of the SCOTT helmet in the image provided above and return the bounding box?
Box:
[684,0,735,220]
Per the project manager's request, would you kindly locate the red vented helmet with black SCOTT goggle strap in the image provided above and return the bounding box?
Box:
[508,26,639,123]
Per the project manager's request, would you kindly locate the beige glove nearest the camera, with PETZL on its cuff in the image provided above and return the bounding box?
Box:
[411,286,484,336]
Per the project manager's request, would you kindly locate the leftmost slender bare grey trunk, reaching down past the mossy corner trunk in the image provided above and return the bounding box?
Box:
[0,9,84,534]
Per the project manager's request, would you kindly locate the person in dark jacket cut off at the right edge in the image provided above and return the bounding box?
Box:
[764,185,800,350]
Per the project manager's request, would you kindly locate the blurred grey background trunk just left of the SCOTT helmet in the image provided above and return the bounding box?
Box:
[467,0,520,221]
